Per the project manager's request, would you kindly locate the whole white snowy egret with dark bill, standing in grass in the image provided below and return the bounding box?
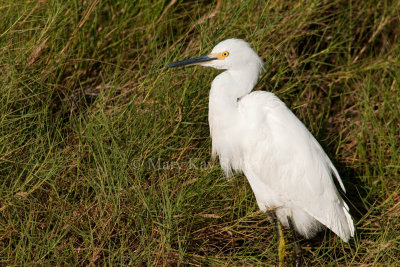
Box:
[166,39,354,266]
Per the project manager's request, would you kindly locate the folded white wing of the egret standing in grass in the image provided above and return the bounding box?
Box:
[239,91,354,241]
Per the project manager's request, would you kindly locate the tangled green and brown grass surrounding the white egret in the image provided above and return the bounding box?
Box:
[0,0,400,266]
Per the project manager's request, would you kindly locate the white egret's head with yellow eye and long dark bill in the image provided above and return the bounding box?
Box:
[165,39,264,70]
